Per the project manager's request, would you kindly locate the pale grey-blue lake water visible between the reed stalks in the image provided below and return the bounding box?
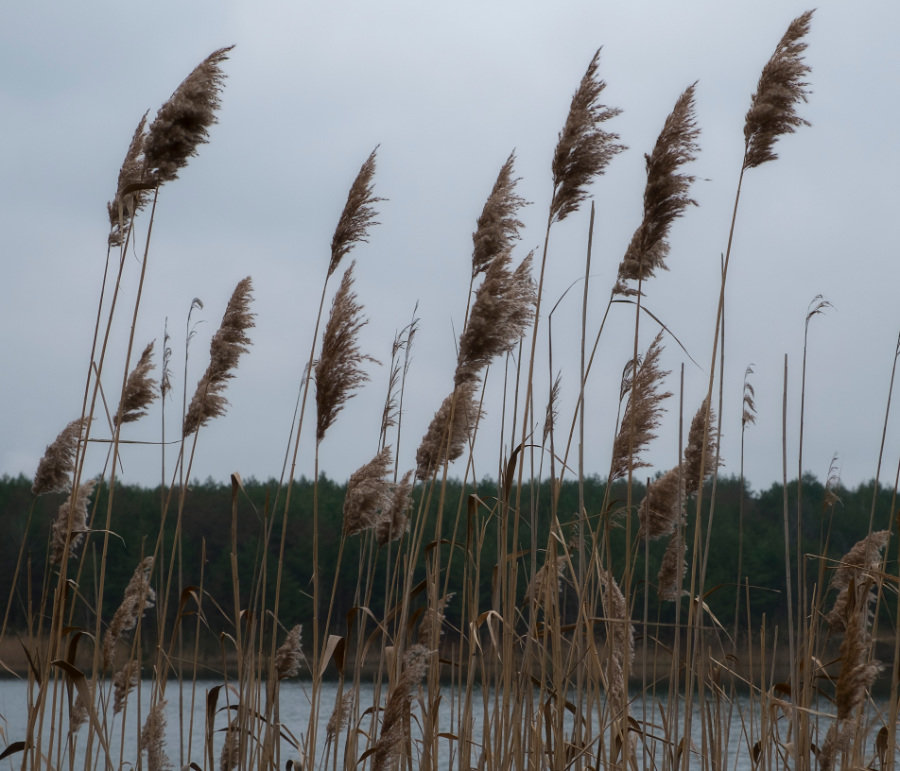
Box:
[0,680,879,771]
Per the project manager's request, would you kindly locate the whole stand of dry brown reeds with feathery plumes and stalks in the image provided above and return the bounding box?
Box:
[7,13,900,771]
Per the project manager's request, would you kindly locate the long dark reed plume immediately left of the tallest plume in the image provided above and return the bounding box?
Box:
[614,83,700,294]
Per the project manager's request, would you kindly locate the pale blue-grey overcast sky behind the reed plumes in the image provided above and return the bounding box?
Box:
[0,0,900,489]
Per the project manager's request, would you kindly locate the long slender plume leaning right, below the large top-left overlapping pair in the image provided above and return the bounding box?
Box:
[183,276,256,436]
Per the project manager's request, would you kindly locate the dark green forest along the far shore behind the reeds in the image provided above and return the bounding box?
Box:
[0,475,896,648]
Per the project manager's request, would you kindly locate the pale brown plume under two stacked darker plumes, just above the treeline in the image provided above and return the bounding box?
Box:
[416,380,481,481]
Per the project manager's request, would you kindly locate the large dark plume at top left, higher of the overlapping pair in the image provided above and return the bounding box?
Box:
[144,46,234,185]
